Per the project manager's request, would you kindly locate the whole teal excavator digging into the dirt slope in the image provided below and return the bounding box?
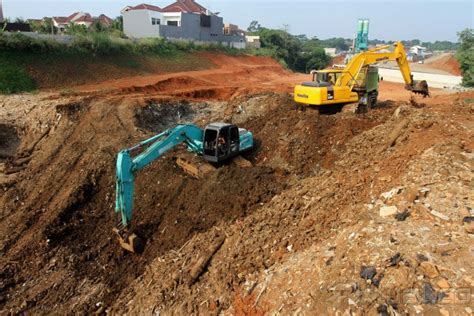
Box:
[114,123,254,253]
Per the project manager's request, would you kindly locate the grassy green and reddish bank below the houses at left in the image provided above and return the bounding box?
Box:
[0,32,245,94]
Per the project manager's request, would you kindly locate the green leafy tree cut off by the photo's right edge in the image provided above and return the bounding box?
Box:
[456,29,474,87]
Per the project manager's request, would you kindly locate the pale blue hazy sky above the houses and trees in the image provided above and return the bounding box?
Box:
[0,0,474,41]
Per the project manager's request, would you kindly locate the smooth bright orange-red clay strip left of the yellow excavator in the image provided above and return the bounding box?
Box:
[74,53,307,100]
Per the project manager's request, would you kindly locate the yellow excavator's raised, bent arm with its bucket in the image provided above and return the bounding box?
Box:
[336,42,429,96]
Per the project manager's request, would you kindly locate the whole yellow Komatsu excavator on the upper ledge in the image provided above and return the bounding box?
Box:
[294,42,429,109]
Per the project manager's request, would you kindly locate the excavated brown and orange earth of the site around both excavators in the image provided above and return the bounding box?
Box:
[0,55,474,315]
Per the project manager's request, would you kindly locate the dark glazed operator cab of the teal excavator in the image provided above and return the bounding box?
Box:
[204,123,240,163]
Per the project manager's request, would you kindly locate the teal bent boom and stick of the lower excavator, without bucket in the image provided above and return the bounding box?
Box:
[115,125,203,229]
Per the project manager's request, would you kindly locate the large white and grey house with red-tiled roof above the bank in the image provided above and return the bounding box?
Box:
[121,0,245,46]
